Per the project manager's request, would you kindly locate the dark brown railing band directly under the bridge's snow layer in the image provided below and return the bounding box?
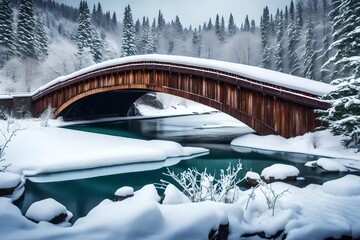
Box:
[32,61,328,109]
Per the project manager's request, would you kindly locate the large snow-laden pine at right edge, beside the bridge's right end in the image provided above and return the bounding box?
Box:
[319,0,360,150]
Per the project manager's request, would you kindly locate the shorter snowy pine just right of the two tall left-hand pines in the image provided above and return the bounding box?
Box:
[35,17,49,60]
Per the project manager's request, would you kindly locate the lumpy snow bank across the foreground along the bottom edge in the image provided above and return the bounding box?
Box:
[0,181,360,240]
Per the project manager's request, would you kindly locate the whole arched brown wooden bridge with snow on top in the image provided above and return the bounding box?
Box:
[32,55,329,137]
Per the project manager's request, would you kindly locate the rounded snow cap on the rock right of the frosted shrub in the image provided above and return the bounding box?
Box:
[261,163,300,181]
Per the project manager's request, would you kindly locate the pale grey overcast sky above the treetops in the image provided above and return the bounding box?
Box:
[55,0,290,27]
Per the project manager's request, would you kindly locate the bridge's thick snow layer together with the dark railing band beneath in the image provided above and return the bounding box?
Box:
[33,54,334,96]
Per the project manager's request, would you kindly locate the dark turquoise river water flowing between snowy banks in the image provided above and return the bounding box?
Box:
[18,114,354,221]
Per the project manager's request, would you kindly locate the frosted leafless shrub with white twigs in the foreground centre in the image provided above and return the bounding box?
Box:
[160,162,243,203]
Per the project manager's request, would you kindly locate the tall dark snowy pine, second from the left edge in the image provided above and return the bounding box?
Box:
[17,0,36,59]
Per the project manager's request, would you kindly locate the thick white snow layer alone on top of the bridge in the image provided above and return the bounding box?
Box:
[33,54,334,96]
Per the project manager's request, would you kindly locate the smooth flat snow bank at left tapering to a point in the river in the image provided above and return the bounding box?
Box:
[6,119,208,179]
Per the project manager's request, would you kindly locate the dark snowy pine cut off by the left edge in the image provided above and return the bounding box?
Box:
[0,0,16,67]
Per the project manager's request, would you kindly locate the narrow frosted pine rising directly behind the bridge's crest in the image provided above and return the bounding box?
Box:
[121,5,136,57]
